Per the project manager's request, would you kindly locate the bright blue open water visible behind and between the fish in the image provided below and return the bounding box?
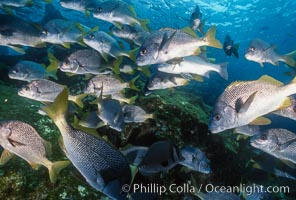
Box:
[0,0,296,198]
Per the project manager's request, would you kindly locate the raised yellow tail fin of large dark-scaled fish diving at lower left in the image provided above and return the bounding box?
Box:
[43,87,68,130]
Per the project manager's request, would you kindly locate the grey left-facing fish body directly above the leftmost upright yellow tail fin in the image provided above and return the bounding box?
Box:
[59,49,110,75]
